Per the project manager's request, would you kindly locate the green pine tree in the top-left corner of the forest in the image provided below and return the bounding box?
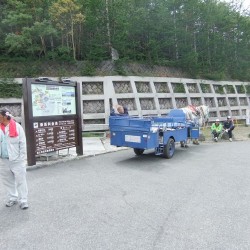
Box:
[3,0,56,56]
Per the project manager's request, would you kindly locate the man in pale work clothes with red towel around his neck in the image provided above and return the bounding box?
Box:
[0,109,29,209]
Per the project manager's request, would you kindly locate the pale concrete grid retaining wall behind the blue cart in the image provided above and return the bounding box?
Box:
[0,76,250,131]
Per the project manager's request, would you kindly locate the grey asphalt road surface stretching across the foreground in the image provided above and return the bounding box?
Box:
[0,139,250,250]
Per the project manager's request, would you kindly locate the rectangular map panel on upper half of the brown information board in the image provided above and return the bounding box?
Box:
[31,83,76,117]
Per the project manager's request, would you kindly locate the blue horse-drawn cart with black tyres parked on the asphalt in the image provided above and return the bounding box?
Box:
[109,109,199,159]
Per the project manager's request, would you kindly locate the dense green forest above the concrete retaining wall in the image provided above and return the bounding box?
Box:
[0,0,250,81]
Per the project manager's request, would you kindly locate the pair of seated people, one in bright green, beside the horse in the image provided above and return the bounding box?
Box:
[211,116,234,142]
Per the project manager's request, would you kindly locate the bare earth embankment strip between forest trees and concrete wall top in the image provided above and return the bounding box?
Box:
[0,60,191,78]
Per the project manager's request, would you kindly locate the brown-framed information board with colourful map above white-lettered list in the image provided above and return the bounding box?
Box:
[23,78,83,166]
